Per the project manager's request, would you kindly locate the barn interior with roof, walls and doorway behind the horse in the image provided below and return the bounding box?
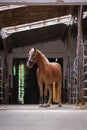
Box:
[0,2,87,104]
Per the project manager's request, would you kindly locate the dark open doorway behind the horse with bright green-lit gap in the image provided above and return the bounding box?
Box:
[13,58,63,104]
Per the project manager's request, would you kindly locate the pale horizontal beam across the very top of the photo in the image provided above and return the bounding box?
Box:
[0,0,87,5]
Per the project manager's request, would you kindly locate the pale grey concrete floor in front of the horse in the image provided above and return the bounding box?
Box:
[0,105,87,130]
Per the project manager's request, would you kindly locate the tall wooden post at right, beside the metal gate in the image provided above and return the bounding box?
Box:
[76,5,83,104]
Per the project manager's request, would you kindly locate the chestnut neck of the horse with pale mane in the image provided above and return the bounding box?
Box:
[37,52,49,70]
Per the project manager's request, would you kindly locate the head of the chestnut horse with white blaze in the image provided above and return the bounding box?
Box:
[27,48,37,68]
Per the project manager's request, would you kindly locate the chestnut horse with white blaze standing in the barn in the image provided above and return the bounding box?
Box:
[27,48,62,106]
